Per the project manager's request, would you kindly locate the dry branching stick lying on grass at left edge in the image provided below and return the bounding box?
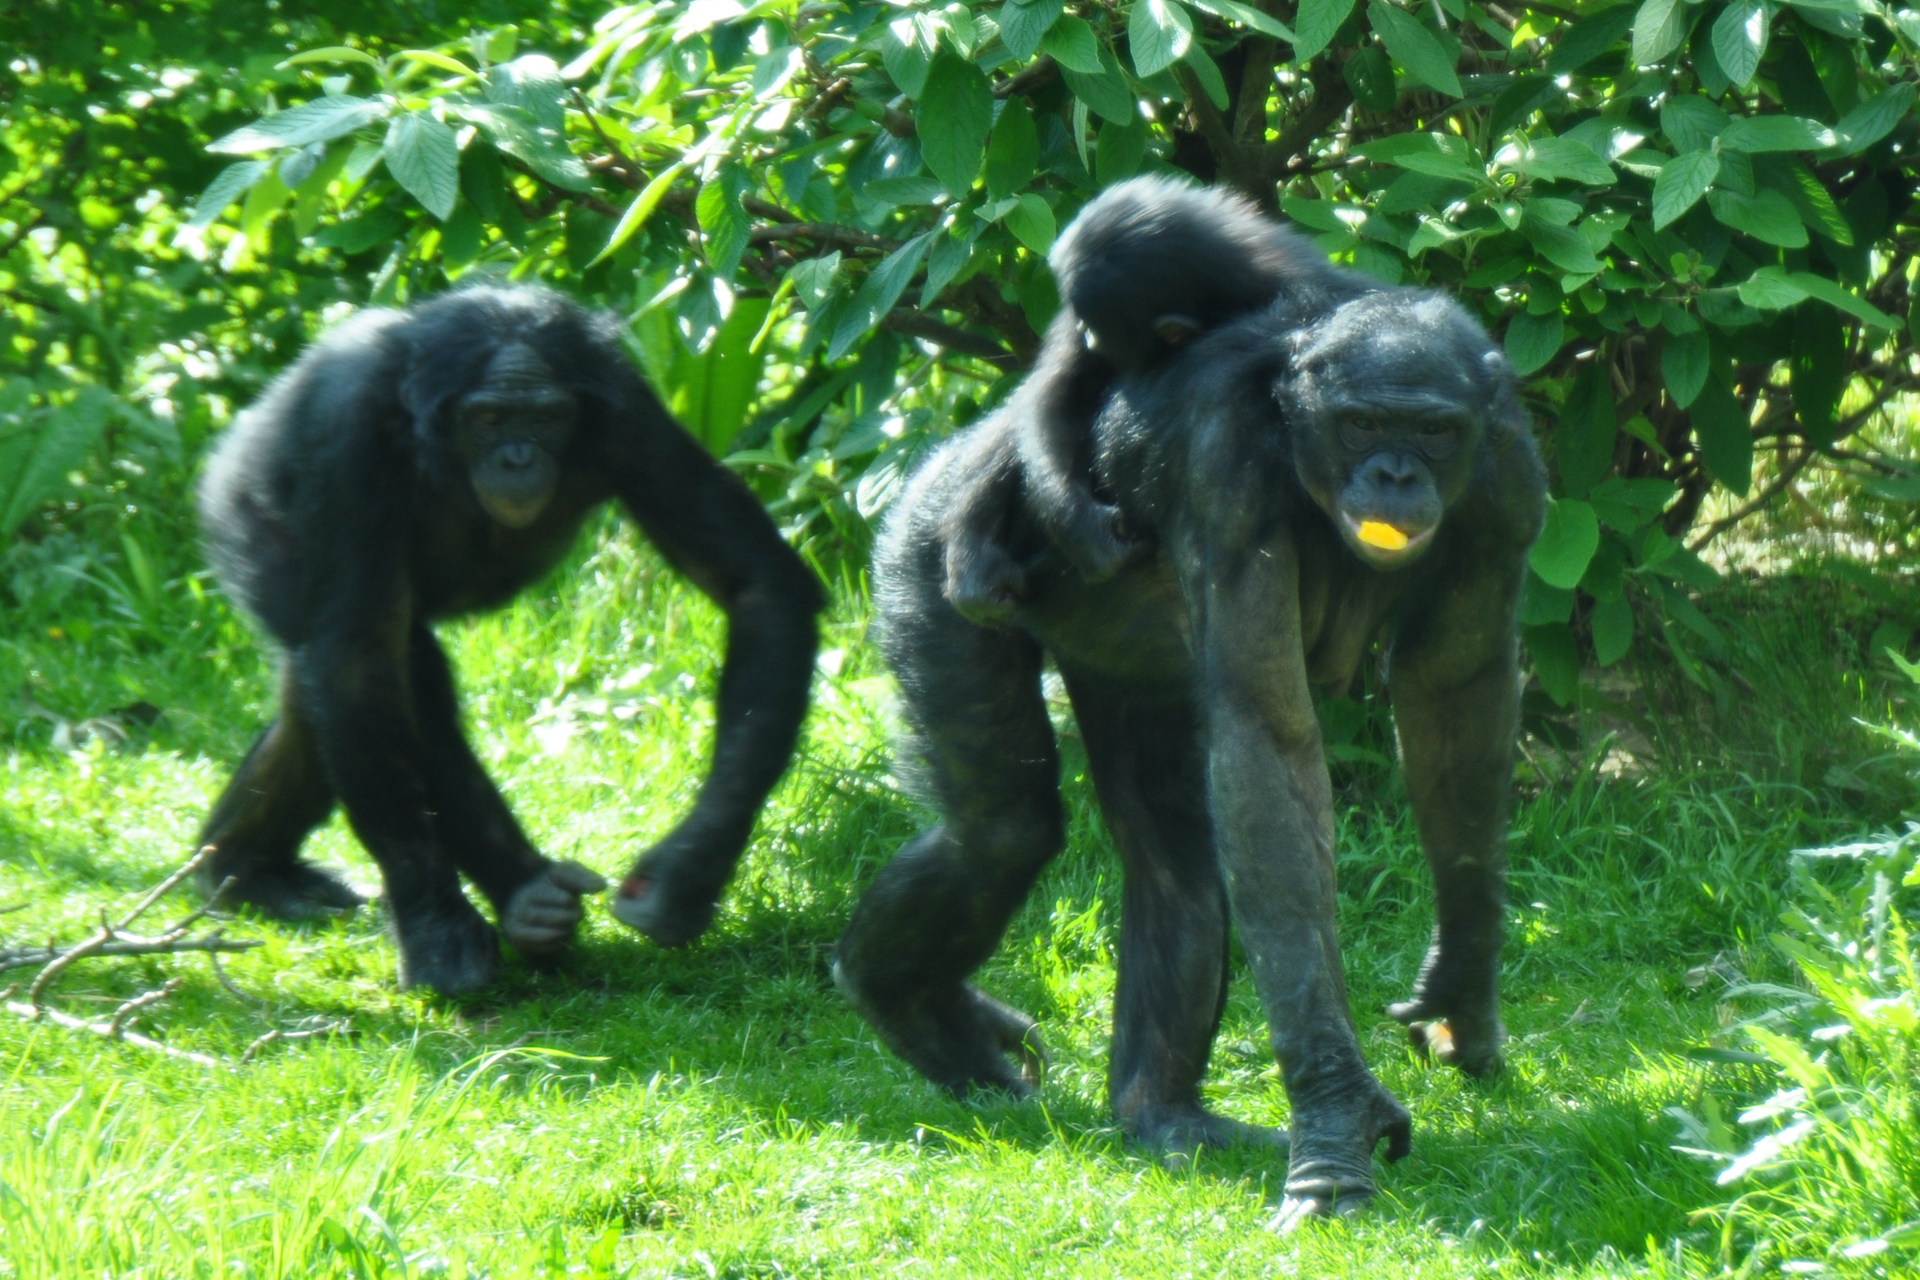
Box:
[0,848,263,1067]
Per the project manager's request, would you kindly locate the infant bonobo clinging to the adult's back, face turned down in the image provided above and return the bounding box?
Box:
[945,178,1363,624]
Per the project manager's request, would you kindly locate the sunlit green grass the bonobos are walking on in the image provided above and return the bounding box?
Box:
[0,532,1912,1280]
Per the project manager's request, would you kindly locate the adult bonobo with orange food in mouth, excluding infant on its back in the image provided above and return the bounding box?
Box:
[835,184,1546,1219]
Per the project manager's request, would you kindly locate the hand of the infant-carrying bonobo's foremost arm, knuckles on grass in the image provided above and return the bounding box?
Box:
[1267,1079,1413,1234]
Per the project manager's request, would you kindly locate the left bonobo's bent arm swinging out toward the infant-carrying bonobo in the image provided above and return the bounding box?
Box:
[599,378,822,946]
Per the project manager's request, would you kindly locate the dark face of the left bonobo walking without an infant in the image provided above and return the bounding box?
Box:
[451,342,580,530]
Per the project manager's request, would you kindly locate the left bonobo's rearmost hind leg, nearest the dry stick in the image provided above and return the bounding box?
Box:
[196,677,361,919]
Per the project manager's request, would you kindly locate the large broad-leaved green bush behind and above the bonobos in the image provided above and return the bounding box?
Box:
[18,0,1920,700]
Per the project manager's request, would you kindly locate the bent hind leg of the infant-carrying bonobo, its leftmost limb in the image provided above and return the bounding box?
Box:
[833,587,1064,1096]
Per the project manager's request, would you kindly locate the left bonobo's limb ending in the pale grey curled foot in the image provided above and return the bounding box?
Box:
[407,626,607,956]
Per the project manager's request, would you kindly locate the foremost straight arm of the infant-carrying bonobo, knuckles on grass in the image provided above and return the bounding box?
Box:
[1175,514,1409,1219]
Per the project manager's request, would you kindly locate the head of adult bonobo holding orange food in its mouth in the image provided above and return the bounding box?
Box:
[1277,292,1513,568]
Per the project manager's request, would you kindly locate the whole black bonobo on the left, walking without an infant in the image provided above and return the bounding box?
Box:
[200,288,820,992]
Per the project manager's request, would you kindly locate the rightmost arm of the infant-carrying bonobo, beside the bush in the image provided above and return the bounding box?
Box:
[1388,539,1523,1075]
